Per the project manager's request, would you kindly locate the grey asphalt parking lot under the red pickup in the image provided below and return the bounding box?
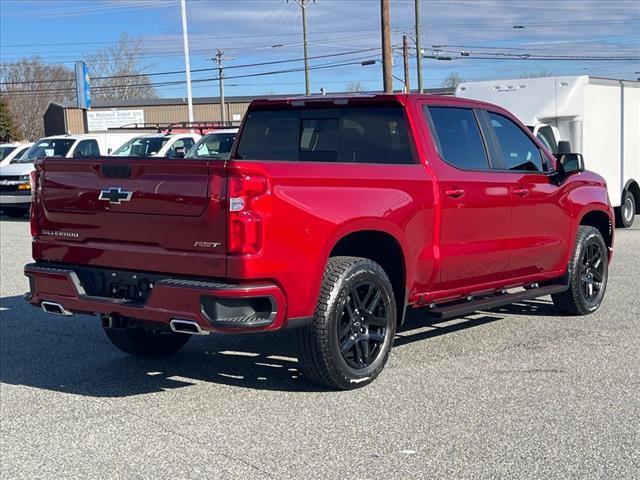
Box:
[0,217,640,479]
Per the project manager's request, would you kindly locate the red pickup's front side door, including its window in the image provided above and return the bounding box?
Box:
[485,111,571,277]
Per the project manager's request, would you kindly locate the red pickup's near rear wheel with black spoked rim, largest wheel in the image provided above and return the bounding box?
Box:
[297,257,396,390]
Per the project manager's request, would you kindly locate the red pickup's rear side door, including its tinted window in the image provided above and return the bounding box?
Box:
[424,103,511,290]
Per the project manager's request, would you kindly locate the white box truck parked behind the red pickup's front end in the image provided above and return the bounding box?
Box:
[456,75,640,227]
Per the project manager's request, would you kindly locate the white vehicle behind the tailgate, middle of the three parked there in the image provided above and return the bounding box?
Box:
[111,133,201,158]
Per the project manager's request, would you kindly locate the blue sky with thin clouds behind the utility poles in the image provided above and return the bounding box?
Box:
[0,0,640,97]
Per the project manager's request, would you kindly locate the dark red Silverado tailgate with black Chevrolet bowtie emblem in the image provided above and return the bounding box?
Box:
[34,158,227,277]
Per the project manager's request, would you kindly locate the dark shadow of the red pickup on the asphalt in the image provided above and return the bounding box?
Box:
[0,296,555,397]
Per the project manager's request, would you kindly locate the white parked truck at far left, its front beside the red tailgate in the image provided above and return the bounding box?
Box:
[0,134,127,218]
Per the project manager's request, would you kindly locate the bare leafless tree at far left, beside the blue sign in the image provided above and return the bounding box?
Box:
[0,57,75,140]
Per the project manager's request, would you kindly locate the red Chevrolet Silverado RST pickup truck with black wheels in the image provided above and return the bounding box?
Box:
[25,94,613,389]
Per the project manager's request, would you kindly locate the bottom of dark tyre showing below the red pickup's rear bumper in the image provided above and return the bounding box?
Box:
[104,328,191,357]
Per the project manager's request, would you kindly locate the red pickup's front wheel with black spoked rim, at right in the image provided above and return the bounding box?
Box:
[551,225,609,315]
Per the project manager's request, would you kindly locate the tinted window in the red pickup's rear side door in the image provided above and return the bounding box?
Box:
[429,107,489,170]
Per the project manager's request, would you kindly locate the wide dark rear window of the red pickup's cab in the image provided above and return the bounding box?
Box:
[237,106,414,164]
